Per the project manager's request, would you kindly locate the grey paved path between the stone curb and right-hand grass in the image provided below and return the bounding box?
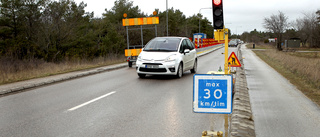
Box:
[241,46,320,137]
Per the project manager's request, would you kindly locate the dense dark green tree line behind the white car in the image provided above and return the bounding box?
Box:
[0,0,213,62]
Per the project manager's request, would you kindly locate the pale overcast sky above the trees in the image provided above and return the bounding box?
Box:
[74,0,320,34]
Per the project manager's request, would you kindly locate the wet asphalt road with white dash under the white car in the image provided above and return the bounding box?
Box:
[0,45,236,137]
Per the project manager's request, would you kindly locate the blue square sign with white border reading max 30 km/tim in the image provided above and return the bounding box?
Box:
[193,74,233,114]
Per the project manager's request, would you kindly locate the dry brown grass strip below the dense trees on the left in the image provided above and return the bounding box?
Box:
[0,55,125,85]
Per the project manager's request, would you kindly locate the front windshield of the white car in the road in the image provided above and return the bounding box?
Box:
[143,38,181,52]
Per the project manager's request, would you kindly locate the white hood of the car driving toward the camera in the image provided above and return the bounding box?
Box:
[139,51,177,61]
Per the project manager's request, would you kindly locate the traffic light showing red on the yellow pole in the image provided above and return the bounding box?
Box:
[212,0,224,29]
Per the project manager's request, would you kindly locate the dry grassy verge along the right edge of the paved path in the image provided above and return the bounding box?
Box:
[247,45,320,106]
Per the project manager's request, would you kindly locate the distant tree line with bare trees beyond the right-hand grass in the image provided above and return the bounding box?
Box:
[232,10,320,50]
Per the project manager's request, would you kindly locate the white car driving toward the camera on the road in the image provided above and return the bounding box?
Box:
[136,37,197,78]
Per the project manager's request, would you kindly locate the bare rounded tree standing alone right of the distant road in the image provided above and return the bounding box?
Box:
[264,11,288,50]
